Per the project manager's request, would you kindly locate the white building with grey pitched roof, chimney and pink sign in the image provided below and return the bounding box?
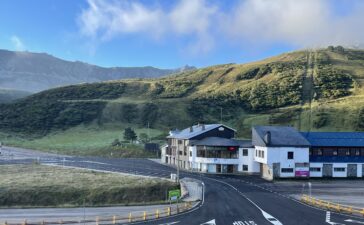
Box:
[252,126,310,180]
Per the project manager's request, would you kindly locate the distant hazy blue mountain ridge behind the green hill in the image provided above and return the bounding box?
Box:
[0,50,195,92]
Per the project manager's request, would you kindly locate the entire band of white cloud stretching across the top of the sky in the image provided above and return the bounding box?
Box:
[78,0,364,54]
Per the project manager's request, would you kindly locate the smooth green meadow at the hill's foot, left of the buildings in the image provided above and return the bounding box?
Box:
[0,124,162,157]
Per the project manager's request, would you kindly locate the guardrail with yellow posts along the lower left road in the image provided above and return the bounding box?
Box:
[3,202,193,225]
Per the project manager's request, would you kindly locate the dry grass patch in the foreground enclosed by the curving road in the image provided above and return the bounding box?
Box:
[0,165,178,207]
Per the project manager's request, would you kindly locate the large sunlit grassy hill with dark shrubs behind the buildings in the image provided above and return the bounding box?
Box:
[0,47,364,156]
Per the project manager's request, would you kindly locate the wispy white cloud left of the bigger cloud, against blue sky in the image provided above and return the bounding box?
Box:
[77,0,217,52]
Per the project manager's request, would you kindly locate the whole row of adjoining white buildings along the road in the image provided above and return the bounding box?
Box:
[162,124,364,180]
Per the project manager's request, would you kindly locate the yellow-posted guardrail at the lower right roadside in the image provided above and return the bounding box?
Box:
[301,195,364,216]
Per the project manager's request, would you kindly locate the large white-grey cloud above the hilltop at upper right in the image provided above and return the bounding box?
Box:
[224,0,364,47]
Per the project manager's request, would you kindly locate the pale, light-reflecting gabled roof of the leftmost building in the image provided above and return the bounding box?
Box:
[167,124,235,139]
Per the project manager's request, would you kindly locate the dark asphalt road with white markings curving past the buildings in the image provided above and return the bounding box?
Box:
[0,147,364,225]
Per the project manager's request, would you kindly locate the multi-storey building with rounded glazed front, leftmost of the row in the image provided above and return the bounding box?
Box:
[162,124,259,173]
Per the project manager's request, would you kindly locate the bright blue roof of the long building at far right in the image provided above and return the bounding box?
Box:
[301,132,364,147]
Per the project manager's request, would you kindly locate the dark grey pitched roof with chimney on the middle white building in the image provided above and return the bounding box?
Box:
[252,126,310,147]
